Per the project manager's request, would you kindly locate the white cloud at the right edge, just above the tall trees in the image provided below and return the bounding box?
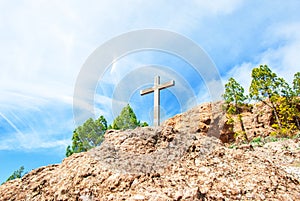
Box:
[224,23,300,90]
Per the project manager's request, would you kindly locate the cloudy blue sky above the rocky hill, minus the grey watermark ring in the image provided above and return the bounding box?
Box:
[0,0,300,182]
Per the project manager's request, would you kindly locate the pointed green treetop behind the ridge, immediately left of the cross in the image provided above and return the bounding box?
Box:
[110,104,148,130]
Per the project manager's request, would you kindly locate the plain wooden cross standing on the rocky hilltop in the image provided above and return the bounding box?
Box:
[140,75,175,126]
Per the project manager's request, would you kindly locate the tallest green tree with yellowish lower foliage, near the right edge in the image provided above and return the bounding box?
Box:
[249,65,300,136]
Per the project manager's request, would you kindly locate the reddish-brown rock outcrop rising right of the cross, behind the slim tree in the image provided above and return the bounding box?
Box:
[163,102,274,143]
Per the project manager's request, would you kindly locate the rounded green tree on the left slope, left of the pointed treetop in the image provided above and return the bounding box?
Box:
[66,116,107,157]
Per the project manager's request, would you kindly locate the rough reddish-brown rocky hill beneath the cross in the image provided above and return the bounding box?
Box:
[0,103,300,201]
